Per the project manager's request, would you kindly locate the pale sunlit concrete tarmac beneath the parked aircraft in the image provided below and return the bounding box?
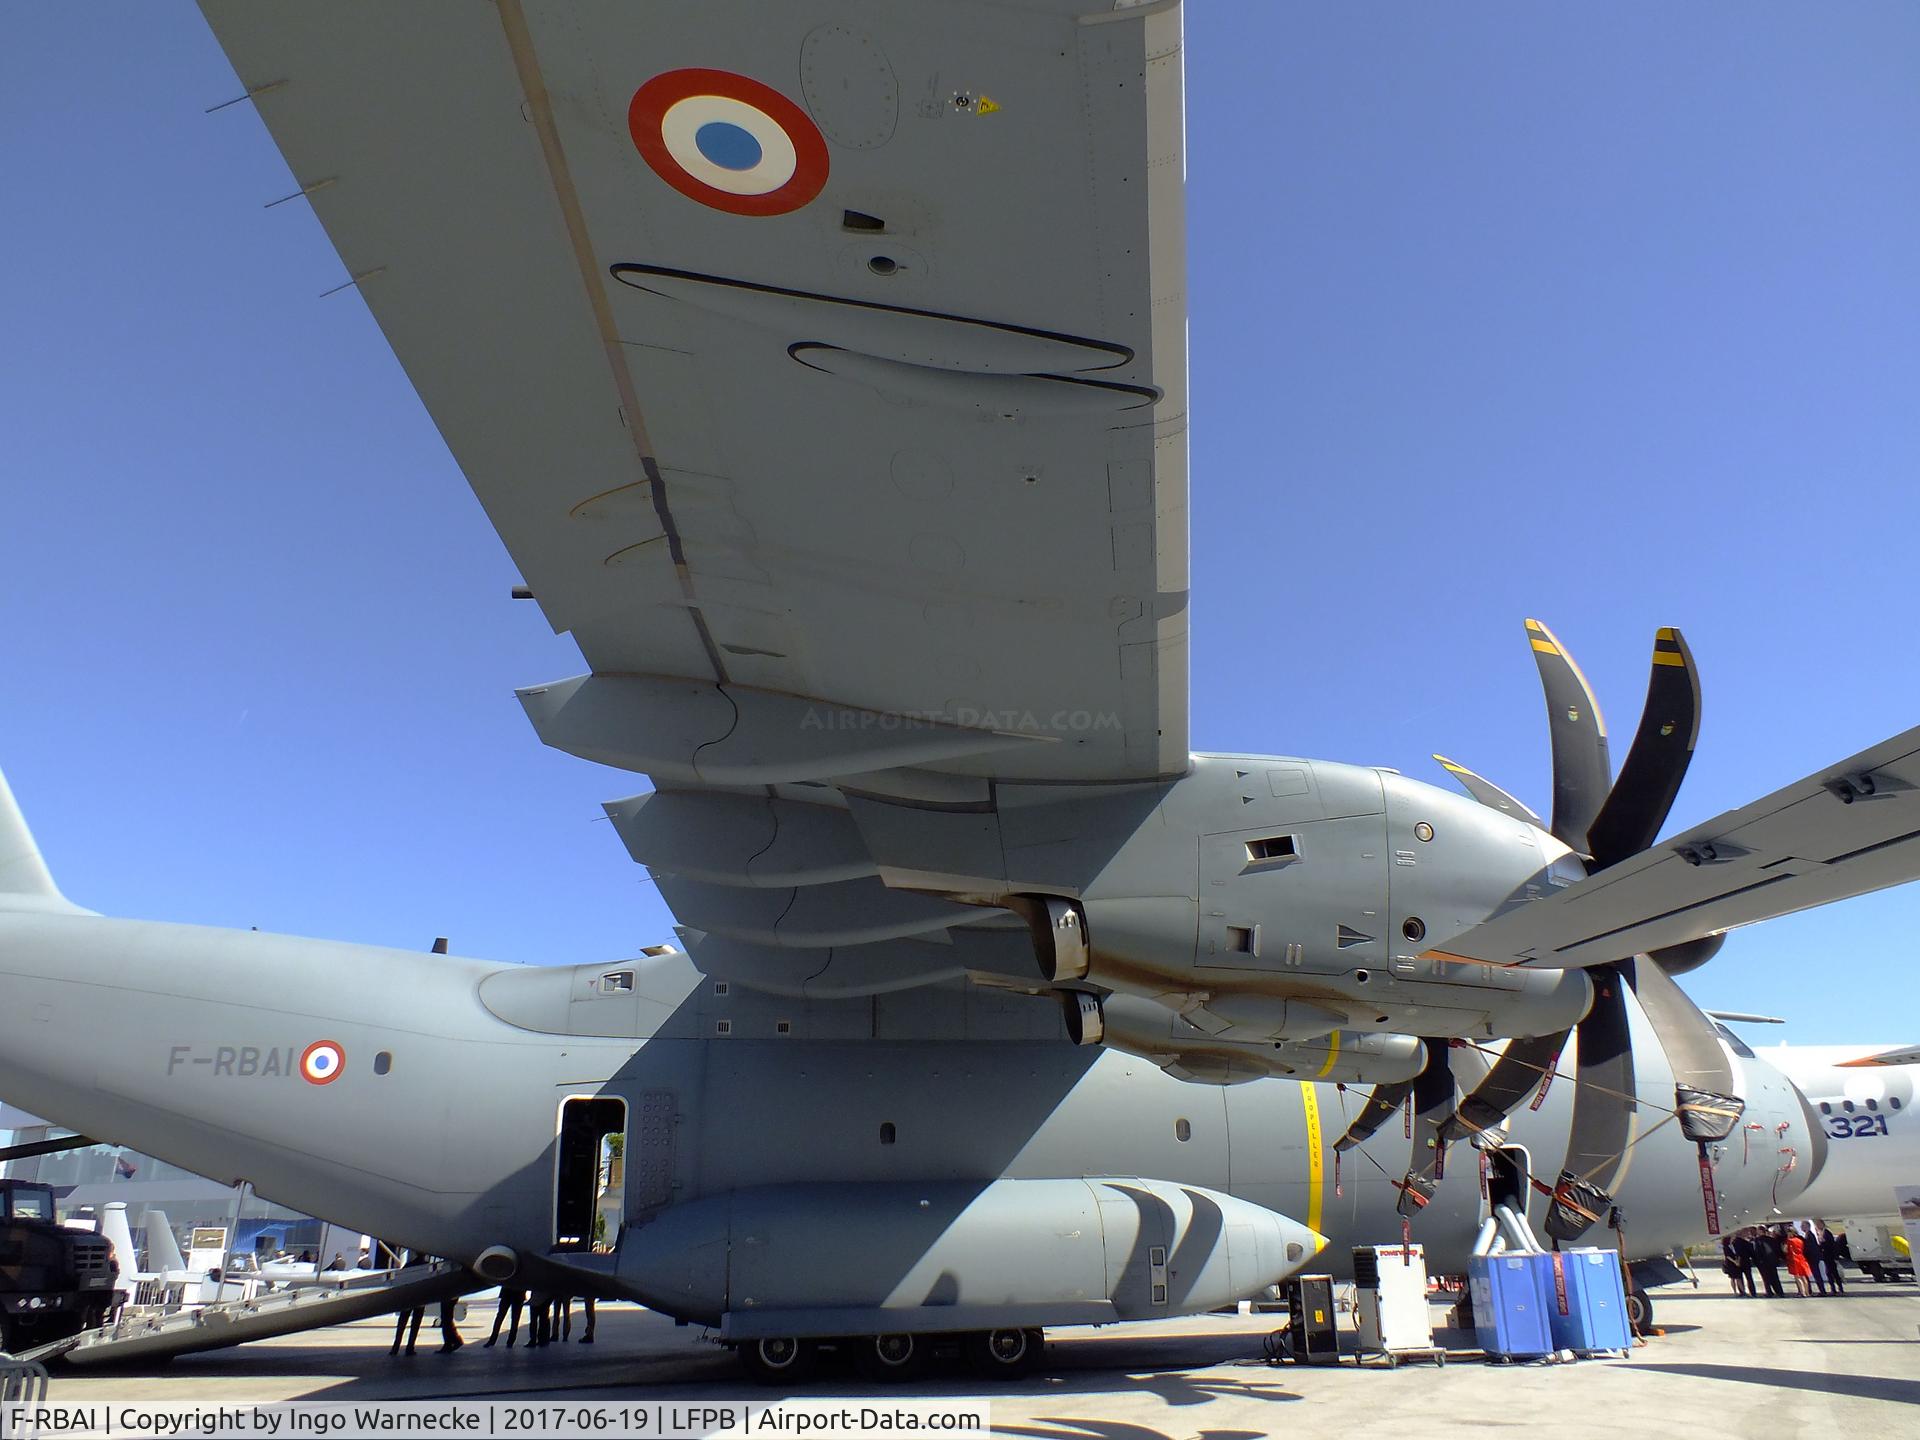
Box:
[30,1273,1920,1440]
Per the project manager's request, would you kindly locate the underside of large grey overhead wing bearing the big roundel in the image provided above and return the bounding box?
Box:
[204,0,1188,993]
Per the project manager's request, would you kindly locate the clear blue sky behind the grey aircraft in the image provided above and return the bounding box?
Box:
[0,0,1920,1041]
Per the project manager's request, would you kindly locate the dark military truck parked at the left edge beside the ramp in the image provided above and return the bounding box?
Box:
[0,1179,121,1356]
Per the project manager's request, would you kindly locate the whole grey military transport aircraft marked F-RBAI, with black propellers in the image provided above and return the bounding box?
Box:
[0,0,1920,1379]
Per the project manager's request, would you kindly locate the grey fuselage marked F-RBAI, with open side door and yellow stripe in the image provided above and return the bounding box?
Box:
[0,899,1824,1321]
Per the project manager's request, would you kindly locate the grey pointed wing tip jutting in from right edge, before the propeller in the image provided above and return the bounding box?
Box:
[1434,728,1920,966]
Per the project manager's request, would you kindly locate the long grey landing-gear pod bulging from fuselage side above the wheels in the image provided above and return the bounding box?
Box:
[618,1179,1327,1340]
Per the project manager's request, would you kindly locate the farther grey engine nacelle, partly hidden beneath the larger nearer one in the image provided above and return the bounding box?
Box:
[1066,993,1427,1085]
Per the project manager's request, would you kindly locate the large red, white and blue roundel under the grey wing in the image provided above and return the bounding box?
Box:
[626,69,828,215]
